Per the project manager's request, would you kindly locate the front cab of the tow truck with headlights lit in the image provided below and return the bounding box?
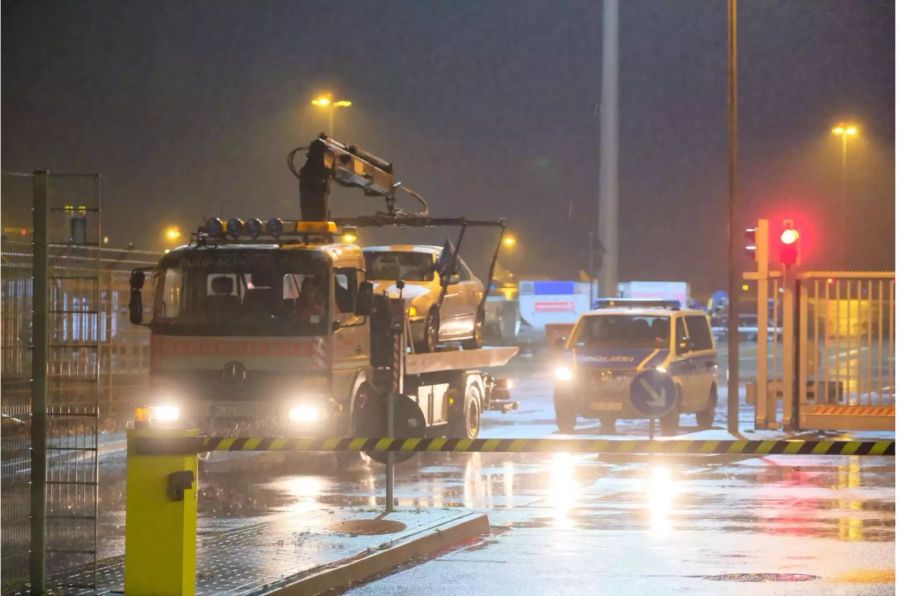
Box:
[132,224,371,434]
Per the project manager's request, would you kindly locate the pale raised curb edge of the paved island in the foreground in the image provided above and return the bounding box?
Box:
[261,513,490,596]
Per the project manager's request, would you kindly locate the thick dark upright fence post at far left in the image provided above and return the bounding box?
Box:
[29,171,50,594]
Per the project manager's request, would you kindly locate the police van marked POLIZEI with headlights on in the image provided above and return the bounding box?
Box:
[553,299,717,434]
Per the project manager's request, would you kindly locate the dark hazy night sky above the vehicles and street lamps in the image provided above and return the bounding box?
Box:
[2,0,894,295]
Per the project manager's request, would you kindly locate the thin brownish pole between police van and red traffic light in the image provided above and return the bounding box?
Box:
[728,0,740,433]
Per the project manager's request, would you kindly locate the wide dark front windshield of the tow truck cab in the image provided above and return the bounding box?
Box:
[153,250,330,335]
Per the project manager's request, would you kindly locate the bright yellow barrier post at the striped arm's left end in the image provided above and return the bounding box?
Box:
[125,429,198,596]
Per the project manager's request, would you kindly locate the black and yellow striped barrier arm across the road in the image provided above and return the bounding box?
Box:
[135,436,894,456]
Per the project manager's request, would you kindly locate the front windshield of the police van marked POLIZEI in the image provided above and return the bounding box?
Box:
[569,315,669,348]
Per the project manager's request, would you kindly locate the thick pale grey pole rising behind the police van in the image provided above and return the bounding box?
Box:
[598,0,619,296]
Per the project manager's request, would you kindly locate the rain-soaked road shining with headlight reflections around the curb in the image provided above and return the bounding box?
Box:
[86,356,895,594]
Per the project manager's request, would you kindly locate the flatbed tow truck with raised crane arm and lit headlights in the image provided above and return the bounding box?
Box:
[129,134,517,438]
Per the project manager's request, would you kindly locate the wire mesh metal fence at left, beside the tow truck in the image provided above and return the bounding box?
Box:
[0,174,157,593]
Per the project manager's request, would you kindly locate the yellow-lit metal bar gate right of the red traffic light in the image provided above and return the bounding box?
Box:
[797,272,896,430]
